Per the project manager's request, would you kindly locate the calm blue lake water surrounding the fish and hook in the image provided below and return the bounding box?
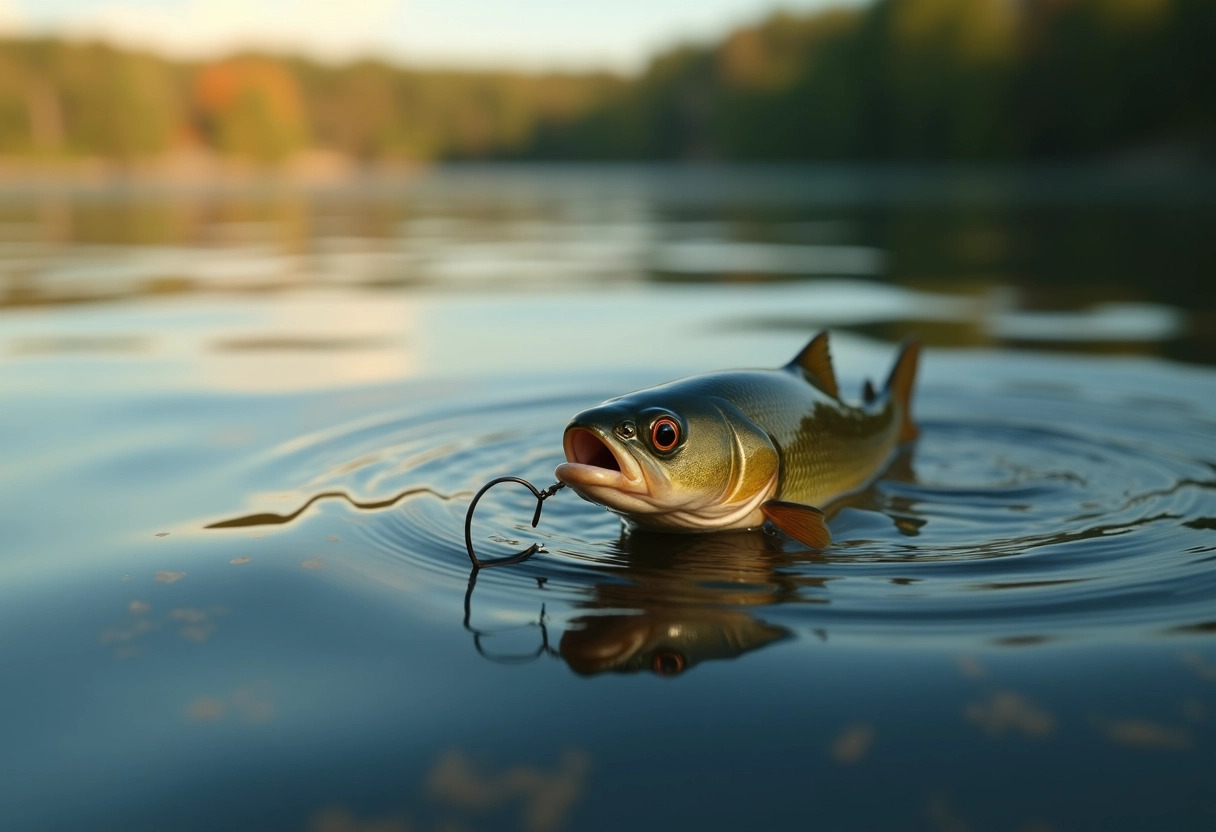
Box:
[0,167,1216,832]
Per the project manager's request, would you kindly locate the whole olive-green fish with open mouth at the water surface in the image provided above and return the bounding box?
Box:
[554,332,921,549]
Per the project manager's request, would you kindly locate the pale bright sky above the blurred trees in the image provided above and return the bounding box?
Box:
[0,0,862,71]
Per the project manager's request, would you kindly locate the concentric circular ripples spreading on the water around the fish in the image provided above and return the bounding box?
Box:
[214,364,1216,663]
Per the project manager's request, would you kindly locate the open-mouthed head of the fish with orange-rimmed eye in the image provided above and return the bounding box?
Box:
[556,387,778,529]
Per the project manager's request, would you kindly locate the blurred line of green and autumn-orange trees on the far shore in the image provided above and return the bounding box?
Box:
[0,0,1216,162]
